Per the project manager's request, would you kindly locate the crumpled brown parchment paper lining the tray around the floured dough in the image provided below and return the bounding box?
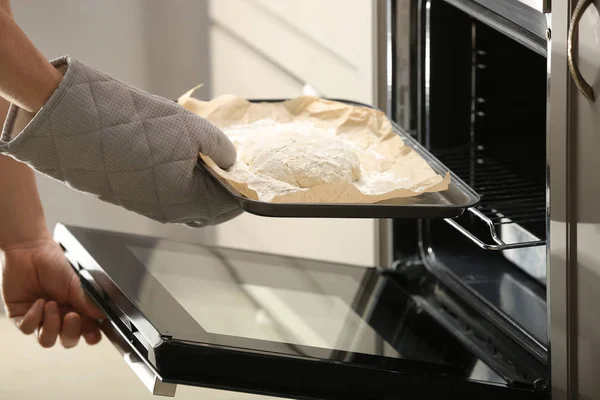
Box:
[179,88,450,204]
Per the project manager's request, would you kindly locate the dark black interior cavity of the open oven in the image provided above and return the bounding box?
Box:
[393,0,548,390]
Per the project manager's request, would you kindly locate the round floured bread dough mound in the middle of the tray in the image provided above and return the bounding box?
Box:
[240,133,360,189]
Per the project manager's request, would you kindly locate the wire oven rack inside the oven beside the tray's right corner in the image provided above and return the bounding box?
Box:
[432,144,546,251]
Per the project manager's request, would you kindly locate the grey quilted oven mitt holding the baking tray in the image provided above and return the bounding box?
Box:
[0,57,241,227]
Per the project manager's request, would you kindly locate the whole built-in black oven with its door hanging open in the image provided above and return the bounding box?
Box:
[55,0,564,400]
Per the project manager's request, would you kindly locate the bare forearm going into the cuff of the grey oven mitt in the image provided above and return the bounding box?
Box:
[0,5,62,112]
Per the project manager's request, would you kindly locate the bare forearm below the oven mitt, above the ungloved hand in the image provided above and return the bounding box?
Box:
[0,0,47,249]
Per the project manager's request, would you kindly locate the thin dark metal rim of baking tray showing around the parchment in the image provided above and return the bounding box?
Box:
[200,99,479,219]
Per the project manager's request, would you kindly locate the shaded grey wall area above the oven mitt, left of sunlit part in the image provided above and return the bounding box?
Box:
[13,0,211,97]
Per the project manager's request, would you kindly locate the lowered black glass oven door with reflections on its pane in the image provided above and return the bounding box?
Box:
[55,225,539,400]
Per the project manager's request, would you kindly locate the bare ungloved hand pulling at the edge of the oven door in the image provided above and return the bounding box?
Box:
[2,232,104,348]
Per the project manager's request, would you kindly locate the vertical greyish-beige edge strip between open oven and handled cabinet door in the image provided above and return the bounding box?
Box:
[546,0,579,400]
